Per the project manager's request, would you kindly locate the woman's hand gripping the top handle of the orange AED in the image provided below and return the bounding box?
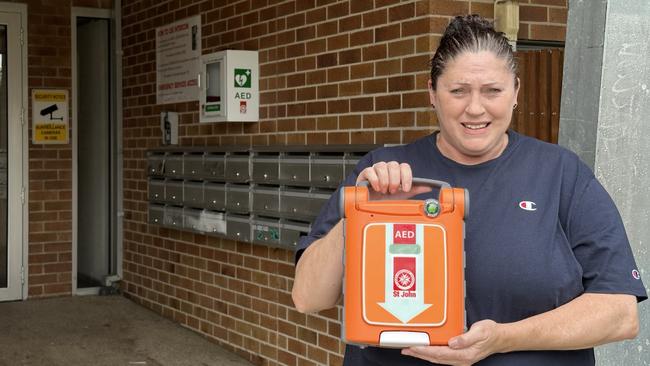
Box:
[357,161,431,199]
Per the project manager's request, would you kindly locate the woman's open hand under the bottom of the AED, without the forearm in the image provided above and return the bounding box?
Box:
[402,320,501,366]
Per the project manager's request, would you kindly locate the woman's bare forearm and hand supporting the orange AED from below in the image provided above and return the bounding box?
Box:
[402,293,639,365]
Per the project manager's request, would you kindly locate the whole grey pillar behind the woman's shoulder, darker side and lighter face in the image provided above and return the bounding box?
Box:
[559,0,650,366]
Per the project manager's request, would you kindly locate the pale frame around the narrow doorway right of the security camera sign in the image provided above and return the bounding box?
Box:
[70,7,124,295]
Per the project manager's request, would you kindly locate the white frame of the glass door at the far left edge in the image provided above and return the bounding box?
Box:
[0,2,29,301]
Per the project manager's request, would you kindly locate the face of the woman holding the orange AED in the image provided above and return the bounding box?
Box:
[429,51,519,165]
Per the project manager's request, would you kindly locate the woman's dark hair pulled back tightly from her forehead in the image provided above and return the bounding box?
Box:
[431,14,518,90]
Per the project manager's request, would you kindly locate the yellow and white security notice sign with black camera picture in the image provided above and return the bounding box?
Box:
[32,89,69,144]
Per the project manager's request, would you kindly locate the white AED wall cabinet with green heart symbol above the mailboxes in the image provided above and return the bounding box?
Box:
[199,50,260,122]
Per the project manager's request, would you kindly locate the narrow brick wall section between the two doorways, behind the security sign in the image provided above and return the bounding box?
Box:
[24,0,112,297]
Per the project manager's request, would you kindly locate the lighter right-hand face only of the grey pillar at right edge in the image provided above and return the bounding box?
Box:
[595,0,650,365]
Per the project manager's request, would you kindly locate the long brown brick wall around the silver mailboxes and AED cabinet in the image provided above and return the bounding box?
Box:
[123,0,566,365]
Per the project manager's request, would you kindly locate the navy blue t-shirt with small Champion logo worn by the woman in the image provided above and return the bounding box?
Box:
[296,131,647,366]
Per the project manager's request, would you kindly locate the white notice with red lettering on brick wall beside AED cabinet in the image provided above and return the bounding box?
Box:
[156,15,201,104]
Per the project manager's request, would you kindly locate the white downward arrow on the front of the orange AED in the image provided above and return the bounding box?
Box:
[378,224,431,323]
